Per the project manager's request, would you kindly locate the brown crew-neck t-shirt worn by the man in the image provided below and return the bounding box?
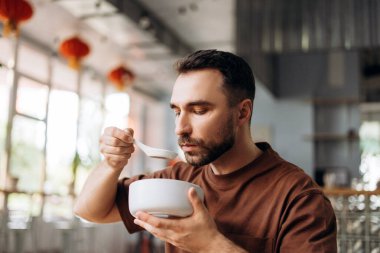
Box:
[116,143,337,253]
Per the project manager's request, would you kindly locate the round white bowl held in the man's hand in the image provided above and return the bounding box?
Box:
[129,178,204,218]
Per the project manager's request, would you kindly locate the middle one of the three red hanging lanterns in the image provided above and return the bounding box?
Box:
[59,36,90,69]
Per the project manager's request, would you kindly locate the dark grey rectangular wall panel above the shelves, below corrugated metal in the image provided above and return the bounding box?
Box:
[275,51,360,99]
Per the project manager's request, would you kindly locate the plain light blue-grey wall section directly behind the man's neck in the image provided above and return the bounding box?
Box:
[251,80,313,175]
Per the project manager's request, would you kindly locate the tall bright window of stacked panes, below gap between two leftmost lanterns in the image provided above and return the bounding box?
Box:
[10,77,48,192]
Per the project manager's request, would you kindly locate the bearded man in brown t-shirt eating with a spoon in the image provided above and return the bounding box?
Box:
[75,50,337,253]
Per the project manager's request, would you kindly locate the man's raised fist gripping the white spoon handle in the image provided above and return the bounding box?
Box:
[100,127,135,171]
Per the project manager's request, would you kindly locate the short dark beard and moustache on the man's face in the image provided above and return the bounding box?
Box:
[178,117,235,166]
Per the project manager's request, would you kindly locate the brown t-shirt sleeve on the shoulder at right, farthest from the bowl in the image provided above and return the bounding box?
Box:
[275,190,337,253]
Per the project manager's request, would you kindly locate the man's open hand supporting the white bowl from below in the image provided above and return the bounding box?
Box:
[134,188,244,252]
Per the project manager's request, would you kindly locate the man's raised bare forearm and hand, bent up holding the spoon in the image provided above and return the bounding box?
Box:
[74,127,134,223]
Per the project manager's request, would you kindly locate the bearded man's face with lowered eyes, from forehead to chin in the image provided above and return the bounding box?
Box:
[171,69,235,166]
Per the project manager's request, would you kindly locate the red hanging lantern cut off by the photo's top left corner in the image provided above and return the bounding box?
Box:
[0,0,33,37]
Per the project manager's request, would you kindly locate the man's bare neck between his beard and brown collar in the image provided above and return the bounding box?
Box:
[210,139,262,175]
